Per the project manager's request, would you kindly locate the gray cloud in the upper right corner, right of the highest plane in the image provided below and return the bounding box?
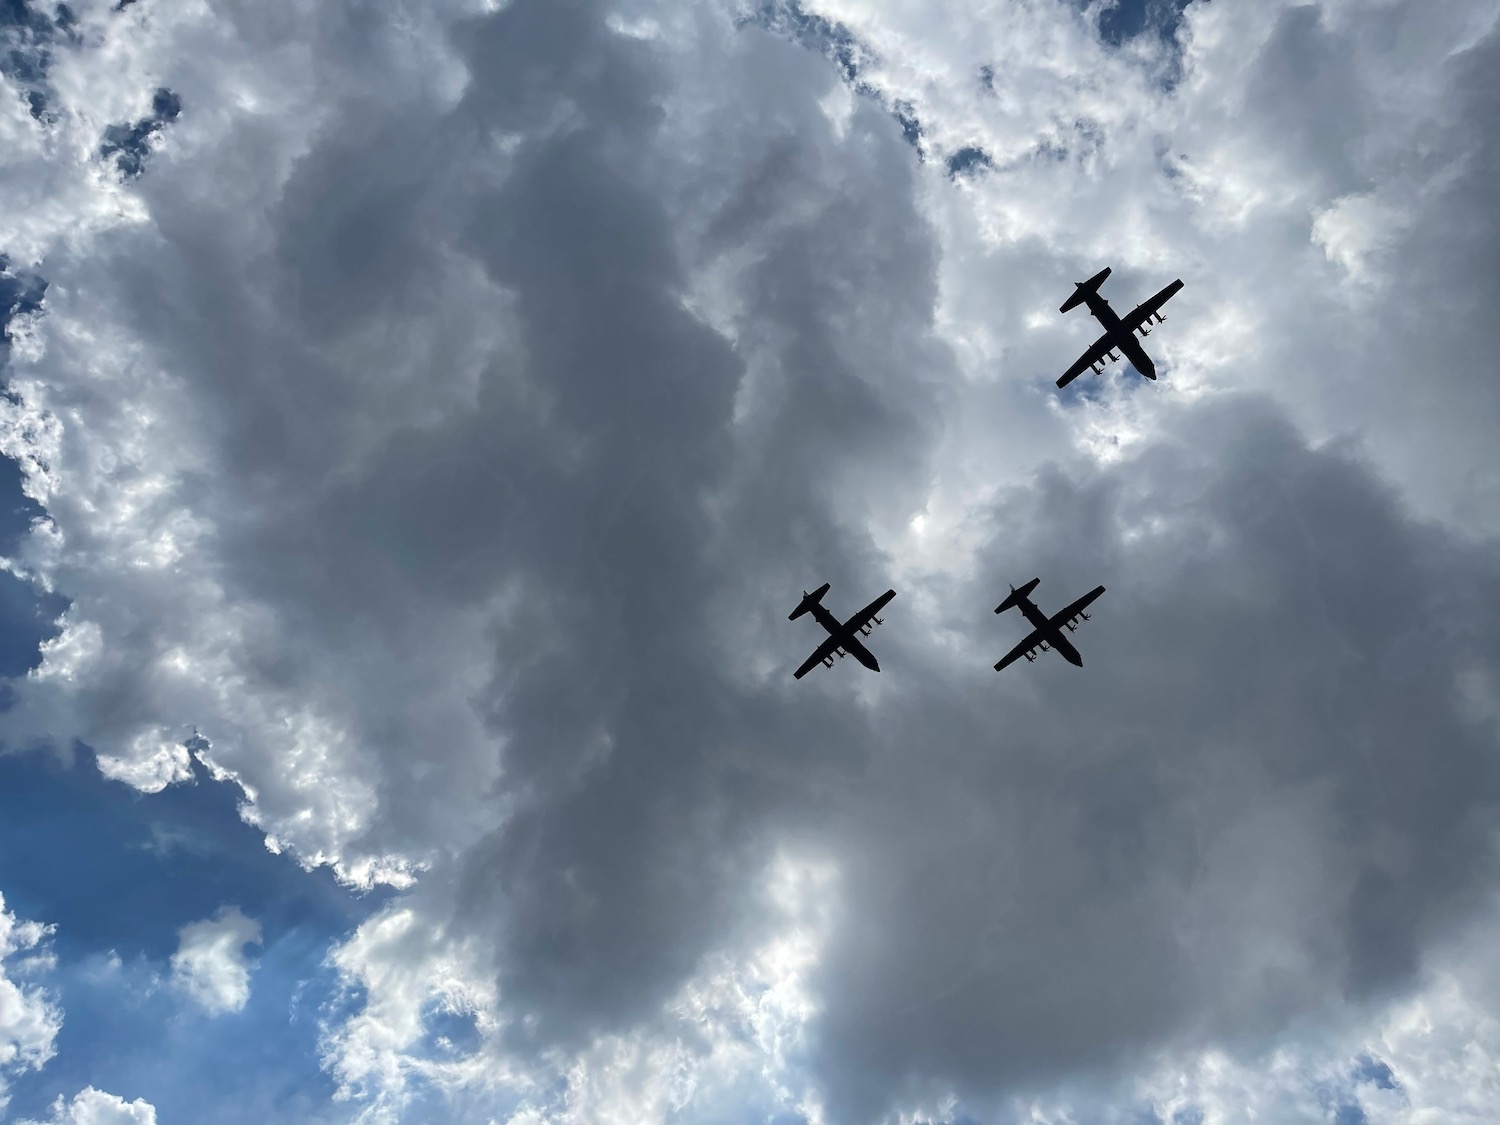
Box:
[1182,5,1500,534]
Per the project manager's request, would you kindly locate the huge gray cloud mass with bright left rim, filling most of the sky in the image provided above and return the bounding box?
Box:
[2,0,1500,1122]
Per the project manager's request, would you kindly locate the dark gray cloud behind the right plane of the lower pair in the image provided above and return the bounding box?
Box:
[824,399,1500,1121]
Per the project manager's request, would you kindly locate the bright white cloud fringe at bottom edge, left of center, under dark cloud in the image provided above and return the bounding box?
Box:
[324,855,837,1125]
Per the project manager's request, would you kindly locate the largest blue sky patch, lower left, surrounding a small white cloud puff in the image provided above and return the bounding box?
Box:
[0,749,393,1124]
